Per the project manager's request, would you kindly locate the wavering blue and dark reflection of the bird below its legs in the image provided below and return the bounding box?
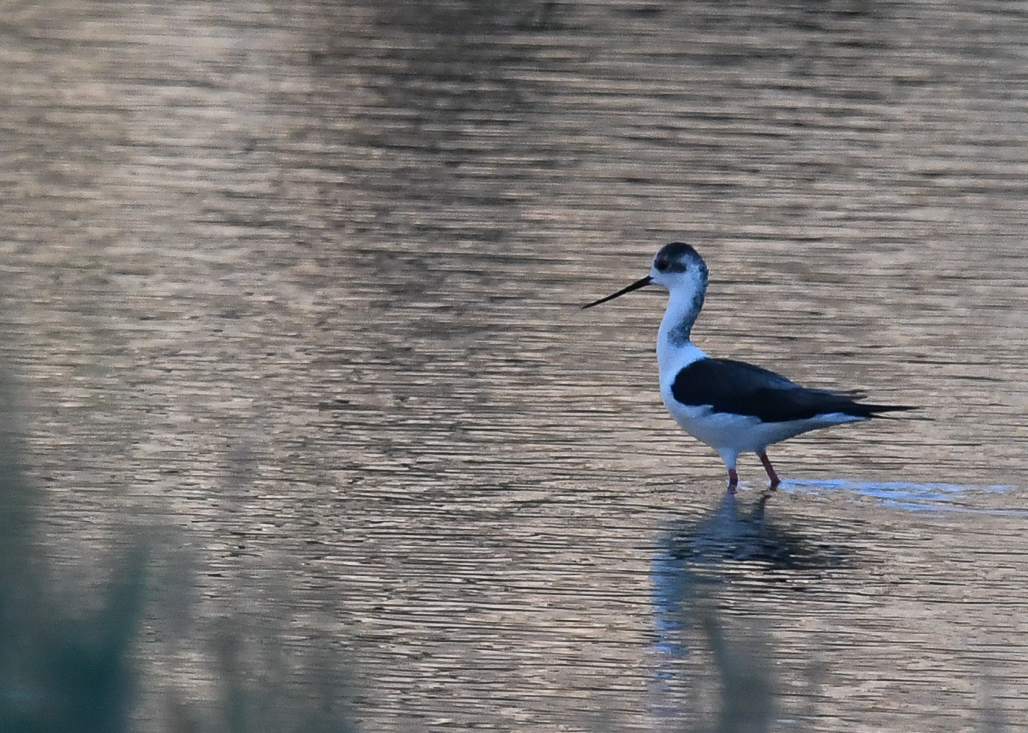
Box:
[652,491,841,730]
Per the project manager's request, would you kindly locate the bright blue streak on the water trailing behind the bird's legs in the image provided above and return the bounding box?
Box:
[778,479,1011,514]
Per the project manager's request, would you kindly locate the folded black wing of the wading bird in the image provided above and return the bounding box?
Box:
[671,359,910,423]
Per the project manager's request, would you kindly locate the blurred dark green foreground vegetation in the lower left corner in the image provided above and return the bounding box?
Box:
[0,372,357,733]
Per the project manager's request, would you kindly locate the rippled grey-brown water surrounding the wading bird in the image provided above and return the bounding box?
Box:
[0,0,1028,731]
